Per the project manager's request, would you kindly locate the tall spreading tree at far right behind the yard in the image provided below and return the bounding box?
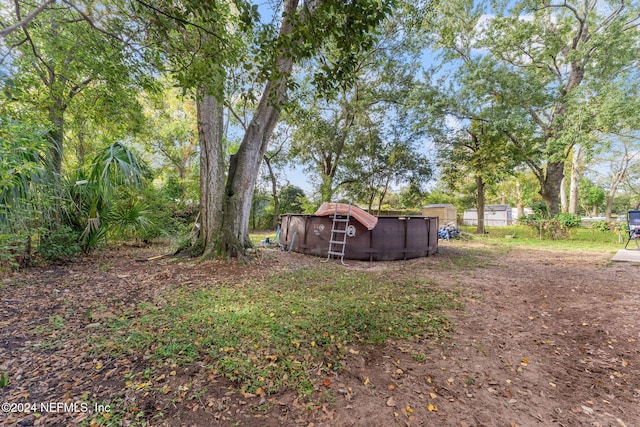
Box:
[428,0,639,214]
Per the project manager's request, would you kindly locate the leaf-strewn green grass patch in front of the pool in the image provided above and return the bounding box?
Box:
[99,264,457,397]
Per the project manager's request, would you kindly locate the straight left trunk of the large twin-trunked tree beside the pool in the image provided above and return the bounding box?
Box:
[196,89,225,257]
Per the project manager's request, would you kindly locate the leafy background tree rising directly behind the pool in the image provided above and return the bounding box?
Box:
[288,10,419,202]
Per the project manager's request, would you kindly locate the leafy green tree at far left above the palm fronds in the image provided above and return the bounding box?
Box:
[5,3,146,175]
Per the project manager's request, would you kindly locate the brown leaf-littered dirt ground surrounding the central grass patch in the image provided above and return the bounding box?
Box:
[0,242,640,427]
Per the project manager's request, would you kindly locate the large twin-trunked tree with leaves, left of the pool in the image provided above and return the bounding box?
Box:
[145,0,393,256]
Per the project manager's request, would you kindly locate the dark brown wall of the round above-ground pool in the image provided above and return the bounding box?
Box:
[280,214,438,261]
